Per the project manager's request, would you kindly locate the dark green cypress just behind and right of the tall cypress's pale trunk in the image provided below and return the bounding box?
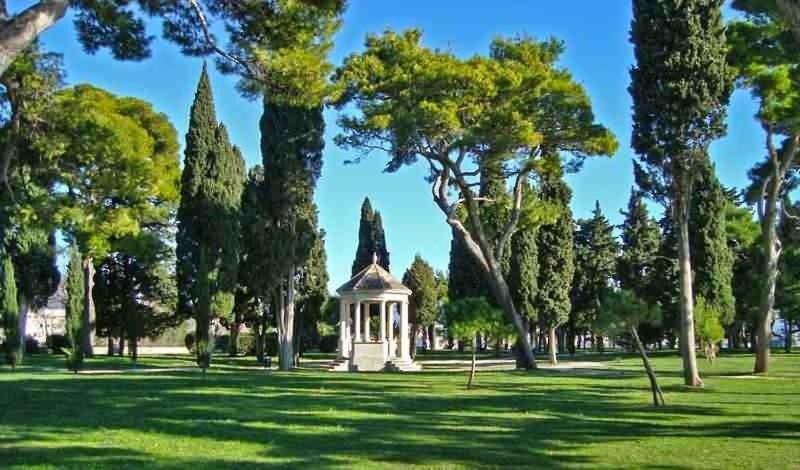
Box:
[689,161,736,325]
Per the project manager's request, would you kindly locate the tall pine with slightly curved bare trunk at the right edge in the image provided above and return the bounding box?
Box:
[729,0,800,373]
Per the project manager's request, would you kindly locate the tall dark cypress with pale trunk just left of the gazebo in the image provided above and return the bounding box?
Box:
[260,99,325,370]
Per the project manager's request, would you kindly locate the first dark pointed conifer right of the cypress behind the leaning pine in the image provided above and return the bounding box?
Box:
[569,201,619,351]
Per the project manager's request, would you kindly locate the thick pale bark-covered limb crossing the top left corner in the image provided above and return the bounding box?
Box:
[0,0,69,75]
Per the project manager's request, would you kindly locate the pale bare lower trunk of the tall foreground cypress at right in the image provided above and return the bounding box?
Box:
[674,185,703,387]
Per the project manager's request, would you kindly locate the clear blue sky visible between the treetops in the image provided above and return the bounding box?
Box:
[37,0,763,290]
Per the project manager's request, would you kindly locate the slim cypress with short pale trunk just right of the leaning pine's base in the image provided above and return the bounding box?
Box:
[536,168,575,364]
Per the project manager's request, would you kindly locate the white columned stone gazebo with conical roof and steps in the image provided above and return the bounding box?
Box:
[333,256,421,371]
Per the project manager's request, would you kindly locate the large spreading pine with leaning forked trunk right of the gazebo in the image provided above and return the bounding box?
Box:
[334,30,617,368]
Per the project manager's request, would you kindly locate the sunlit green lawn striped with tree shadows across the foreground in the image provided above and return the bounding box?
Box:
[0,353,800,469]
